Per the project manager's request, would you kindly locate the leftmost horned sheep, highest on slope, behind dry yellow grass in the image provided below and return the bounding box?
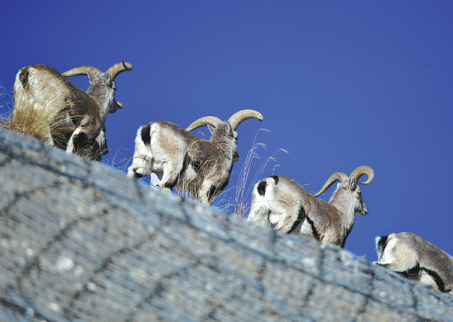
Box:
[13,62,133,154]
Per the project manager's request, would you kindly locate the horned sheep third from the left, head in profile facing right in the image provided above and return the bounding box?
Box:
[247,166,374,247]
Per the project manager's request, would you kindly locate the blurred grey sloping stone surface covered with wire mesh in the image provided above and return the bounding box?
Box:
[0,128,453,322]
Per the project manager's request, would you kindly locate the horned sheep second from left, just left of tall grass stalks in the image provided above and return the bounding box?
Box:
[128,110,263,205]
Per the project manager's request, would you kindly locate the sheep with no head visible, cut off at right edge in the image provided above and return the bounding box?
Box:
[373,232,453,295]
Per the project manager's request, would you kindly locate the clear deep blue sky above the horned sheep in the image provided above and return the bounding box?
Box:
[0,1,453,260]
